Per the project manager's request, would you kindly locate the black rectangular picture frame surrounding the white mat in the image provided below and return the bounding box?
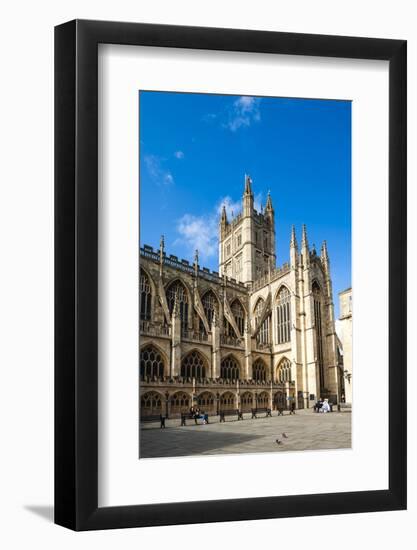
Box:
[55,20,407,531]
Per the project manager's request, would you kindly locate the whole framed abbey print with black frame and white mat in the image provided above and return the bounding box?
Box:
[55,21,406,530]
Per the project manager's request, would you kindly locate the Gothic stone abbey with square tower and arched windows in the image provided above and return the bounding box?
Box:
[140,176,344,417]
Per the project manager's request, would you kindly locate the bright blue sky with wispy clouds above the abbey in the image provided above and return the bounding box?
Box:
[139,91,351,320]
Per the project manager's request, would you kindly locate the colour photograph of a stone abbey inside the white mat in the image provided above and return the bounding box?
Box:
[138,90,353,459]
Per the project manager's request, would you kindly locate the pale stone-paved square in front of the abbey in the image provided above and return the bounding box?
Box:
[140,409,351,458]
